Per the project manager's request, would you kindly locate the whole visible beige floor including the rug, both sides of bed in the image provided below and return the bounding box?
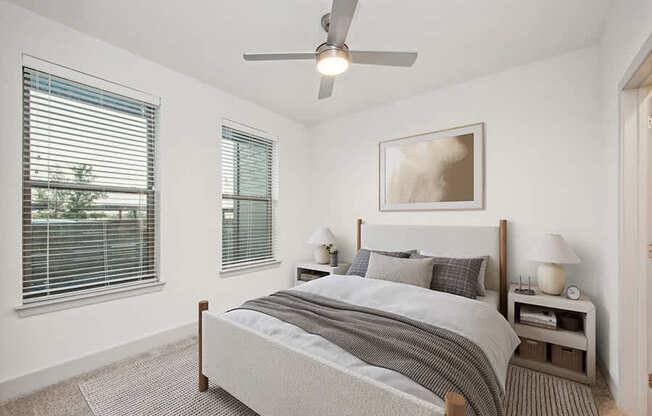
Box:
[0,338,621,416]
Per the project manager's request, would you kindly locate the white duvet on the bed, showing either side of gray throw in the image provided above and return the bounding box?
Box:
[222,275,519,406]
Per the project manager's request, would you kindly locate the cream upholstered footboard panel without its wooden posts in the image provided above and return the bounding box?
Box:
[202,311,445,416]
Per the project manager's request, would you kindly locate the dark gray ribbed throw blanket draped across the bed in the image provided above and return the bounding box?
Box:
[235,290,505,416]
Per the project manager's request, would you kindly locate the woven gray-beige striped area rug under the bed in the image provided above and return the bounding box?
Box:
[79,345,598,416]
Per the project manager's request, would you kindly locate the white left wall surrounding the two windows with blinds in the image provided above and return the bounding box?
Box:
[0,1,310,394]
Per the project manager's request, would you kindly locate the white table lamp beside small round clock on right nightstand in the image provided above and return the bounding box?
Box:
[528,234,580,295]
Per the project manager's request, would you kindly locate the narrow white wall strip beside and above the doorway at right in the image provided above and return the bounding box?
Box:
[597,0,652,410]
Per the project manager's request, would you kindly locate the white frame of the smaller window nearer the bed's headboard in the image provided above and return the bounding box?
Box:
[218,118,281,275]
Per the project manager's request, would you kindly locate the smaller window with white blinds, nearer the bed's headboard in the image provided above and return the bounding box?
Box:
[221,123,278,270]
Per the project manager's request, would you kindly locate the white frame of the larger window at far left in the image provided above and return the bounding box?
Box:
[16,54,160,304]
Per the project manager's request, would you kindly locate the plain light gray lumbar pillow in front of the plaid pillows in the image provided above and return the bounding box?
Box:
[365,253,435,288]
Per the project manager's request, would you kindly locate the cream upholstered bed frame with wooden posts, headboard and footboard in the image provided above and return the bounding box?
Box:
[198,219,507,416]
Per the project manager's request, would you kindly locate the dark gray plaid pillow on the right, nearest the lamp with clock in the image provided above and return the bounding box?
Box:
[411,254,484,299]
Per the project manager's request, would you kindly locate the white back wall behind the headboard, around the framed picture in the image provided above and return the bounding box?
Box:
[309,47,615,368]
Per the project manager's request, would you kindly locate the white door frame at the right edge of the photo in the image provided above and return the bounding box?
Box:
[617,36,652,415]
